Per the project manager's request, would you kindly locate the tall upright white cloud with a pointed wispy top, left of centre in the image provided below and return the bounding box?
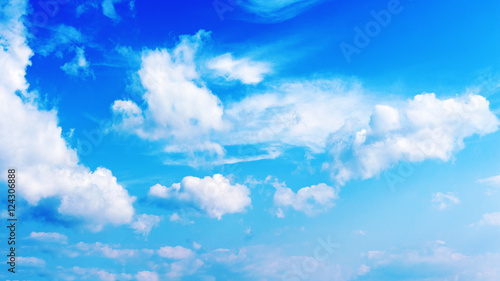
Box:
[113,30,224,154]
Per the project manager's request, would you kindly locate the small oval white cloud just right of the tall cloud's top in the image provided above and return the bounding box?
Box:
[207,53,271,84]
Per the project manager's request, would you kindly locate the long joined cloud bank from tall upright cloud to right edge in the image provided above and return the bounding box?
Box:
[113,31,499,175]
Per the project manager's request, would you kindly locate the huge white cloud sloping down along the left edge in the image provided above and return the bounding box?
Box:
[0,1,135,230]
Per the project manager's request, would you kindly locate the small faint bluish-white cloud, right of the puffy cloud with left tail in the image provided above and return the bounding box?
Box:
[272,177,338,214]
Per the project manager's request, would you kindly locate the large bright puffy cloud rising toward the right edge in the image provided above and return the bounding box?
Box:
[331,94,499,184]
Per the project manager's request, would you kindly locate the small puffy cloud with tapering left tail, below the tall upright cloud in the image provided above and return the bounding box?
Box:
[149,174,251,219]
